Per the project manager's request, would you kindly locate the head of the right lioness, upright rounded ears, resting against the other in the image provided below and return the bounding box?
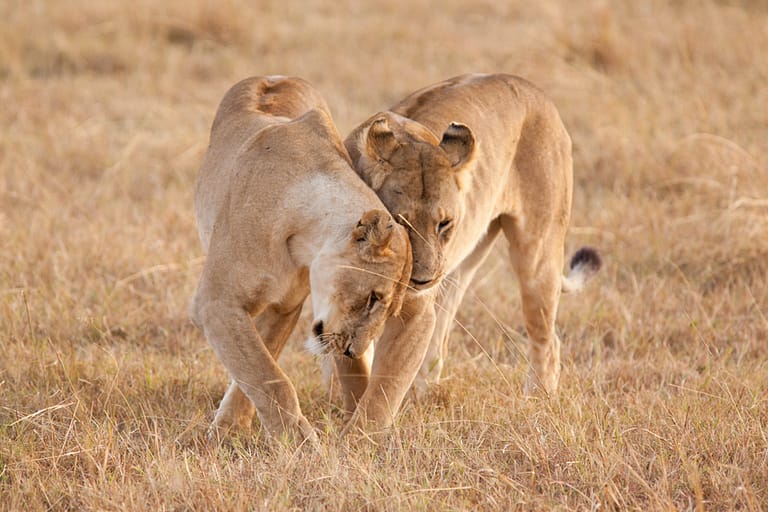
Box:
[347,112,475,290]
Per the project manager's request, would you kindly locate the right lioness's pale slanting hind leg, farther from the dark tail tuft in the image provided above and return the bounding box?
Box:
[414,219,500,393]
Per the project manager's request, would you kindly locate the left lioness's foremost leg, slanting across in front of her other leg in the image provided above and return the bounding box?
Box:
[195,300,317,444]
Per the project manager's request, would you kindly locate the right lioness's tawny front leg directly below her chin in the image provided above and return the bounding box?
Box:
[342,295,435,436]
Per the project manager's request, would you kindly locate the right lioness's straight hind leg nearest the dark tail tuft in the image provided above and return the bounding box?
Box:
[502,216,564,394]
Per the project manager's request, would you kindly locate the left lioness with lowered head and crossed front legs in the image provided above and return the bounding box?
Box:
[190,77,422,443]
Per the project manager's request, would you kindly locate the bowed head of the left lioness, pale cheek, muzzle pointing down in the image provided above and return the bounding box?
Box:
[310,210,412,358]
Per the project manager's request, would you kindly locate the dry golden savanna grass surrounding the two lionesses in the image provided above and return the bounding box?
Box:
[0,0,768,510]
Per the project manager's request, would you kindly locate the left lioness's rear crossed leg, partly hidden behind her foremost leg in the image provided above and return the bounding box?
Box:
[212,305,301,435]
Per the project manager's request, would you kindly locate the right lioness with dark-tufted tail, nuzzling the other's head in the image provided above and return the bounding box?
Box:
[345,74,600,393]
